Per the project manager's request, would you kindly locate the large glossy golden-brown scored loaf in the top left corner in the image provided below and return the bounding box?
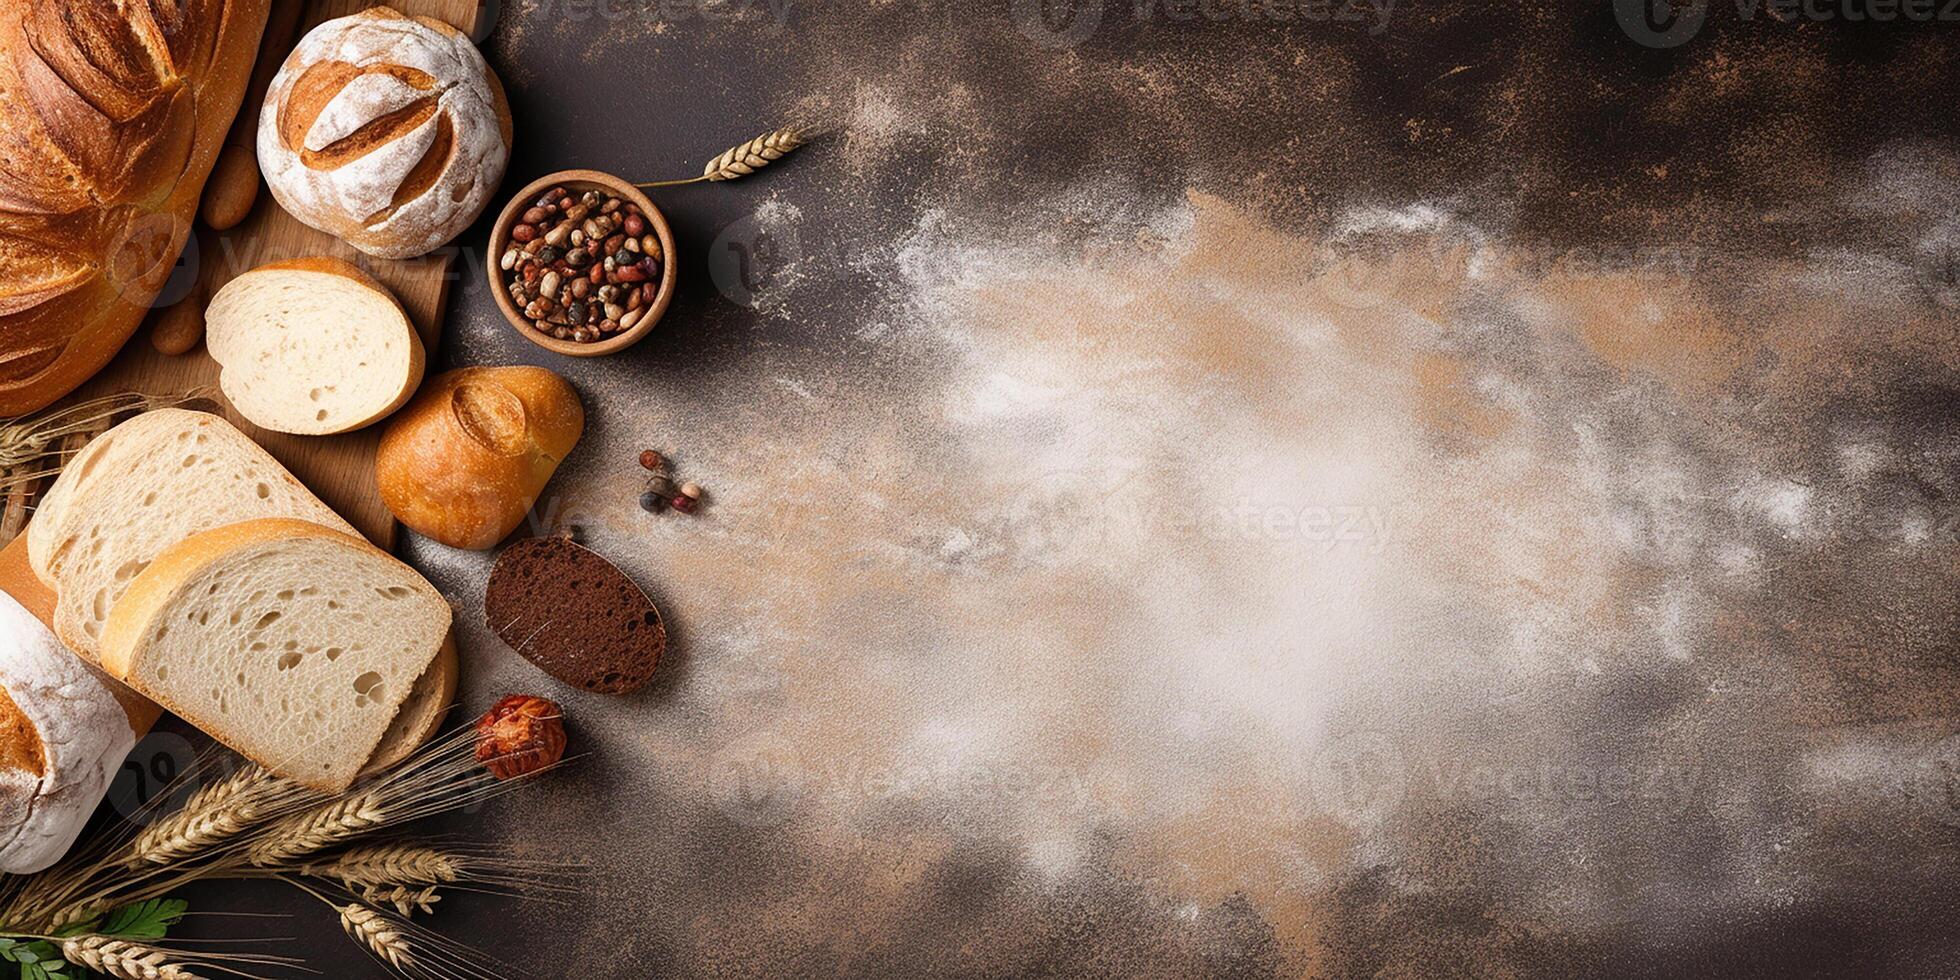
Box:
[0,0,269,416]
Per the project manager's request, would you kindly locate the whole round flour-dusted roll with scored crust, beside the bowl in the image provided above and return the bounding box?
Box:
[259,6,512,259]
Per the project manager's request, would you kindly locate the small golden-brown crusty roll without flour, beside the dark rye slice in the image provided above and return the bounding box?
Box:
[374,367,586,549]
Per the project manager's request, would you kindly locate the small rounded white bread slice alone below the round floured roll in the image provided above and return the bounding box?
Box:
[204,257,425,435]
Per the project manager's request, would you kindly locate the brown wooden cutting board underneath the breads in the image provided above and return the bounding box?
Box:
[0,0,484,551]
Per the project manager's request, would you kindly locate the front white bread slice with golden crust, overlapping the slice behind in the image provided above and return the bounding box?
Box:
[102,517,451,792]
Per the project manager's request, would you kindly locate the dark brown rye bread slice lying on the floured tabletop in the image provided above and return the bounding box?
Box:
[484,535,666,694]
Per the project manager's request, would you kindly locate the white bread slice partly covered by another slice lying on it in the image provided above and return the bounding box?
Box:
[27,408,355,661]
